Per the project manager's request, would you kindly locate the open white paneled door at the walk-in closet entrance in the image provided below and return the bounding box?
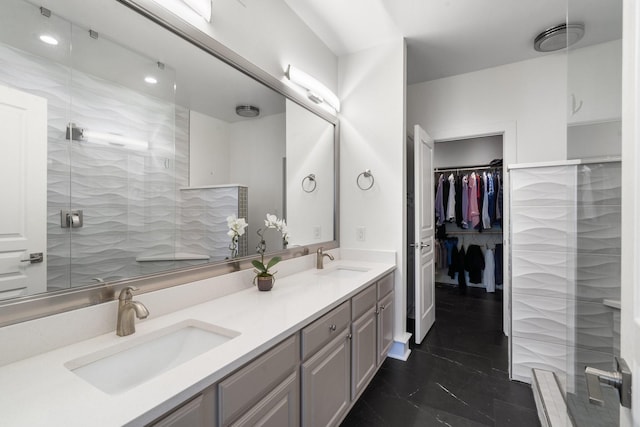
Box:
[413,125,436,344]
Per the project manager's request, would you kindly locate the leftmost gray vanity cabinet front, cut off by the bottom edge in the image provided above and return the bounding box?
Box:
[149,386,216,427]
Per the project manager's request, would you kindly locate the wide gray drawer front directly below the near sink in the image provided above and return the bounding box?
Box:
[218,334,300,426]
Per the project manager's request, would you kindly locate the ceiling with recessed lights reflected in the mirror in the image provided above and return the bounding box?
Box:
[0,0,285,123]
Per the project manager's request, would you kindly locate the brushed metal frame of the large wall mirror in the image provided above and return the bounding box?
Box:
[0,0,340,327]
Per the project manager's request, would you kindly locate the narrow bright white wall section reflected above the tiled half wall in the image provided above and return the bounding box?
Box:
[189,110,230,187]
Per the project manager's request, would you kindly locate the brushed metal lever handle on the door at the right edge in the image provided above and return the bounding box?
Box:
[584,357,631,408]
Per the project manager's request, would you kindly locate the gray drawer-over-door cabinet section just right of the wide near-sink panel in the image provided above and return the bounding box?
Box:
[301,301,351,427]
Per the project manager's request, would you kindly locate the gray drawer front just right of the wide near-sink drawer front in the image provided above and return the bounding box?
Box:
[302,301,351,360]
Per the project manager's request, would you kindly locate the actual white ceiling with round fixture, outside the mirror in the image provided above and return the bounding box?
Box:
[285,0,622,84]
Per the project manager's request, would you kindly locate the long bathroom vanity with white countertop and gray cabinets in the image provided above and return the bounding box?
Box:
[0,251,395,426]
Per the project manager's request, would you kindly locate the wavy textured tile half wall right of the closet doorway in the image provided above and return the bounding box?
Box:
[511,163,621,392]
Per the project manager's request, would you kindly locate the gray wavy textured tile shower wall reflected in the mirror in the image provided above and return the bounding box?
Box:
[0,40,247,289]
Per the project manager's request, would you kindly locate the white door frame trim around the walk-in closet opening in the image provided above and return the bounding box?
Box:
[429,121,518,377]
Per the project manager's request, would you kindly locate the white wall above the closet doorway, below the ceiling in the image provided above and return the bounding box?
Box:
[407,50,567,163]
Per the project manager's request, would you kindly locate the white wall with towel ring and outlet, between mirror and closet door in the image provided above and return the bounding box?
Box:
[339,39,406,339]
